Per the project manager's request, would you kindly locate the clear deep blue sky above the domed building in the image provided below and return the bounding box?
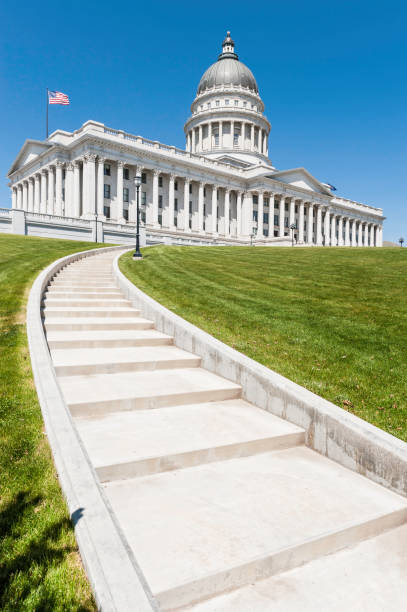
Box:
[0,0,407,240]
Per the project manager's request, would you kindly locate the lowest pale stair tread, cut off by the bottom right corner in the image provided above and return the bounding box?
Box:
[183,525,407,612]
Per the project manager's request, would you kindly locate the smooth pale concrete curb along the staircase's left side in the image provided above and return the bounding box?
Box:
[26,245,158,612]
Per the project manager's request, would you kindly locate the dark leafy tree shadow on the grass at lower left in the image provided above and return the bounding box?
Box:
[0,491,89,612]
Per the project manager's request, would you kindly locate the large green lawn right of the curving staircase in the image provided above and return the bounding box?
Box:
[120,246,407,441]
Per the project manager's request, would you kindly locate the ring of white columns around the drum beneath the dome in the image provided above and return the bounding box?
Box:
[186,120,268,155]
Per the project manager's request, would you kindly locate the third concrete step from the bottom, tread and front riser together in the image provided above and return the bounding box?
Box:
[76,399,304,481]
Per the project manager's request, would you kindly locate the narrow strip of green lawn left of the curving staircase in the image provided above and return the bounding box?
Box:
[0,235,105,612]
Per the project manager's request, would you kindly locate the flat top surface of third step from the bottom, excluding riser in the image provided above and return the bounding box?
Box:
[76,399,304,467]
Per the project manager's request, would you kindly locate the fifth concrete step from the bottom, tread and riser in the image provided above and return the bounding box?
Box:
[51,346,201,376]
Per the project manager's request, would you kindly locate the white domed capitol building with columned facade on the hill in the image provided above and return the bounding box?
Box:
[6,32,384,246]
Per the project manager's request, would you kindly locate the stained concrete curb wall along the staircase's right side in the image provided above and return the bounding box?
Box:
[113,249,407,497]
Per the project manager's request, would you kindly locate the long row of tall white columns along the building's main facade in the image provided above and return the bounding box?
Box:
[12,153,382,246]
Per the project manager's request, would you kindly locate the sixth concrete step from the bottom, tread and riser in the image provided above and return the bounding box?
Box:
[47,329,174,350]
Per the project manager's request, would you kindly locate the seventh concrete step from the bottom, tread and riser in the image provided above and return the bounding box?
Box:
[44,316,154,333]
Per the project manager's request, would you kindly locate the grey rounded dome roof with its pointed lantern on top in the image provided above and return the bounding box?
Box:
[197,32,259,94]
